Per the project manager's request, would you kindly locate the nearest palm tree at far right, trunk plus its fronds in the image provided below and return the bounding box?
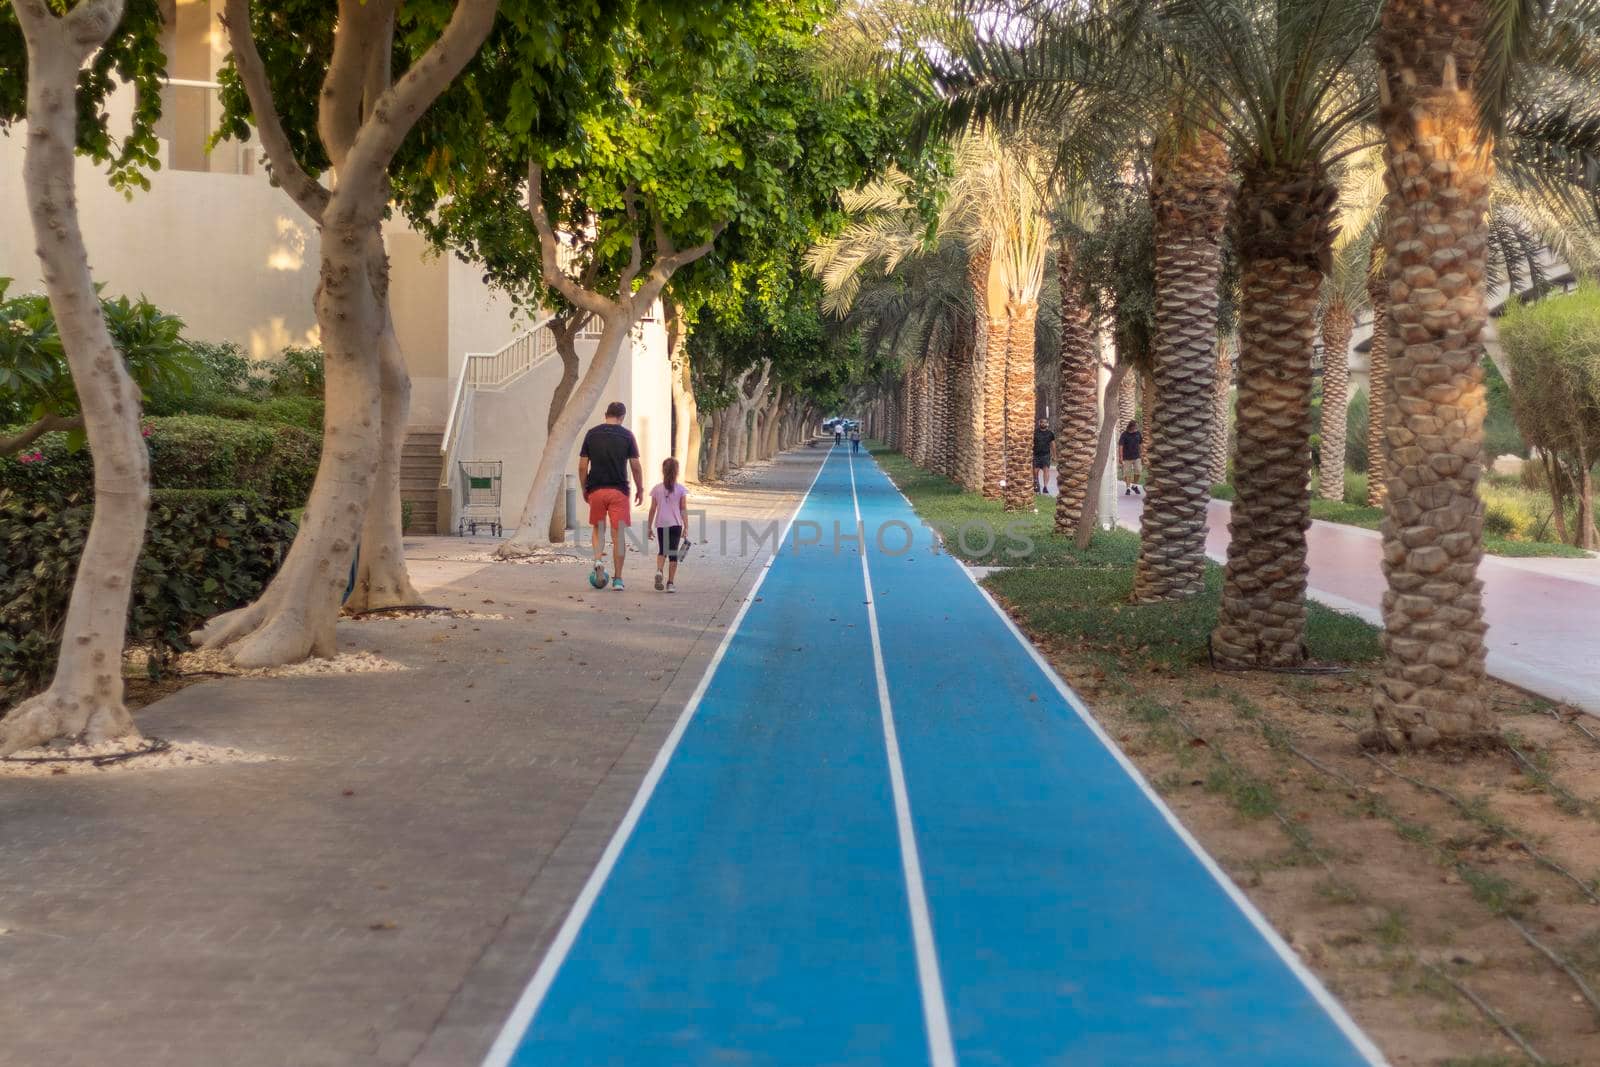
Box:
[1371,0,1600,747]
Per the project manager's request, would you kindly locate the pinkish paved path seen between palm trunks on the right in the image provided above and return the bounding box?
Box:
[1117,496,1600,715]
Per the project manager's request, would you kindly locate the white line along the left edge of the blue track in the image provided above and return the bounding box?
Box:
[483,444,829,1067]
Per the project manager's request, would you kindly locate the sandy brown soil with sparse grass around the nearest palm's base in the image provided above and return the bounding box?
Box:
[1004,604,1600,1067]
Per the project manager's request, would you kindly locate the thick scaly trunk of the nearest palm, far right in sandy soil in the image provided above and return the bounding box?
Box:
[1374,0,1496,747]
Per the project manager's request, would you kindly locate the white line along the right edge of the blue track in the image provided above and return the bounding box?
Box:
[850,457,1389,1067]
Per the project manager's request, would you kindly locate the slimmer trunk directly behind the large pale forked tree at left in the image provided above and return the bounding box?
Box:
[344,273,422,611]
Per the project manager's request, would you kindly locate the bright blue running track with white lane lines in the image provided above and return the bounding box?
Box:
[485,448,1382,1067]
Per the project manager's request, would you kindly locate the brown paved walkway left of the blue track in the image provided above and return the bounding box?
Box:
[0,450,824,1067]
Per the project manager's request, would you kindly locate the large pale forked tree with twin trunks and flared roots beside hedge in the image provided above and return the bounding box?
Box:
[195,0,499,665]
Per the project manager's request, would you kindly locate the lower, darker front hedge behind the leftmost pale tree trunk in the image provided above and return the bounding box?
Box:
[0,490,294,709]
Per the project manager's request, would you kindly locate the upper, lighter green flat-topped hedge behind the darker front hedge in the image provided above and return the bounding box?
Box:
[0,414,322,509]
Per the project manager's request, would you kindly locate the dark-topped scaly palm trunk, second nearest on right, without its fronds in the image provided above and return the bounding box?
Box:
[1209,168,1338,667]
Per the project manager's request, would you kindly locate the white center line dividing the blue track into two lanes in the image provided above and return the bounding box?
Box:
[846,453,955,1067]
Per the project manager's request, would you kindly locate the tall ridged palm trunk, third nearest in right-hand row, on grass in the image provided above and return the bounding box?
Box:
[1133,133,1234,603]
